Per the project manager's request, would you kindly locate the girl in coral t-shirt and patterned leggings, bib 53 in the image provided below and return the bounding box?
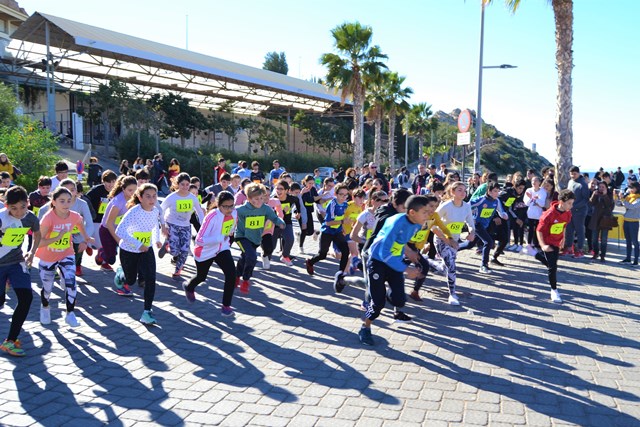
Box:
[36,187,93,328]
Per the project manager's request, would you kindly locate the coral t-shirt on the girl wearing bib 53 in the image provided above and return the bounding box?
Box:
[36,210,83,262]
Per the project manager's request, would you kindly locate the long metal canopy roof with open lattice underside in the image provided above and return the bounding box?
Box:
[2,12,351,115]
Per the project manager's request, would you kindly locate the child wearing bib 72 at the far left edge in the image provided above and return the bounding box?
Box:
[0,186,40,356]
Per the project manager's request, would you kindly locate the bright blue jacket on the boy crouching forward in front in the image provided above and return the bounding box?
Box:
[369,213,422,272]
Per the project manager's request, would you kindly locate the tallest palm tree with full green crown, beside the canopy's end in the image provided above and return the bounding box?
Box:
[320,22,387,166]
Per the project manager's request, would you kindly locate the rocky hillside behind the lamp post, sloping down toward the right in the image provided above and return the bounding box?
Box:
[435,109,552,175]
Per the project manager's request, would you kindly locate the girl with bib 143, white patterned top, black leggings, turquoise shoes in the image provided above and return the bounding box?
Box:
[116,184,161,325]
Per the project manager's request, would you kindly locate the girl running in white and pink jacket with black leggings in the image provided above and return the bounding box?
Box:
[182,191,238,316]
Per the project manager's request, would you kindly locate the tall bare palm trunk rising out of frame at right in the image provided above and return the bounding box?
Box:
[552,0,573,188]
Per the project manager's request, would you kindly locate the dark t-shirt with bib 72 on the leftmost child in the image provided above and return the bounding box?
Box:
[0,209,40,266]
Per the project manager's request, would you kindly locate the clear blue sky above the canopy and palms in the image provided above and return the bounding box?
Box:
[19,0,640,170]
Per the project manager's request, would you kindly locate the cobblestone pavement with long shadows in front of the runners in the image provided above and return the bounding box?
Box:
[0,219,640,427]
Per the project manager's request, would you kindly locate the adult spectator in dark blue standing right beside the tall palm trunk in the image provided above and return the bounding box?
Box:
[562,166,591,258]
